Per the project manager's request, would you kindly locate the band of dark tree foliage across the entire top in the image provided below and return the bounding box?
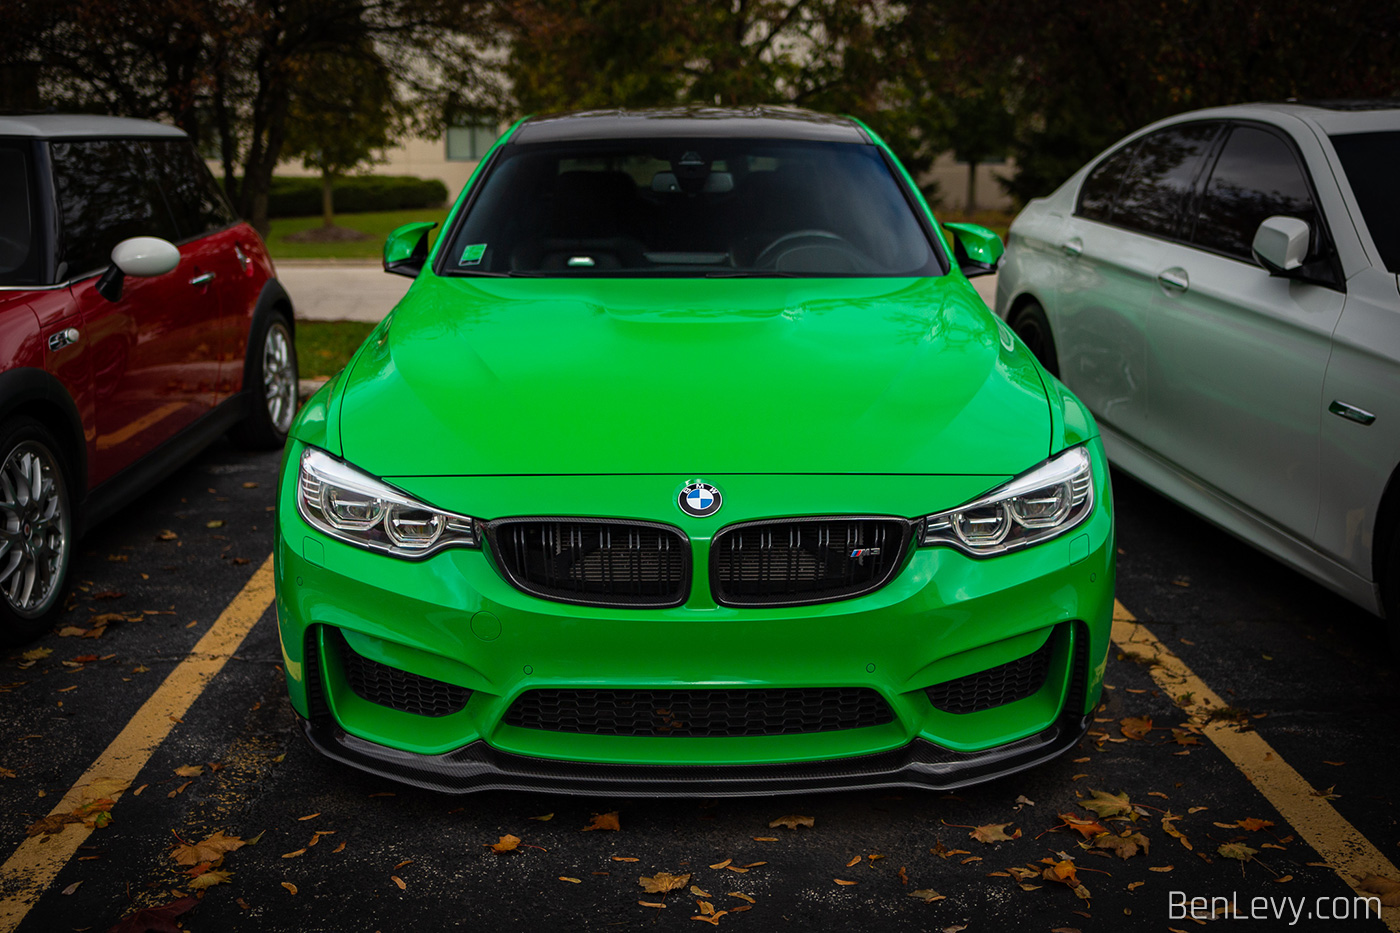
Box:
[0,0,1400,215]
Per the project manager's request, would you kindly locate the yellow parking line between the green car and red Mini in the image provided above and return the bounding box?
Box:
[0,556,273,933]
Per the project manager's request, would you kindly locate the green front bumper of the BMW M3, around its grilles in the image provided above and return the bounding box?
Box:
[276,441,1114,796]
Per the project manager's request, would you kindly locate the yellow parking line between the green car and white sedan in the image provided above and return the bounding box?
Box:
[1113,600,1400,933]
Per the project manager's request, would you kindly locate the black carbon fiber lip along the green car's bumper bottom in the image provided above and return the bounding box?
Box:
[301,716,1091,797]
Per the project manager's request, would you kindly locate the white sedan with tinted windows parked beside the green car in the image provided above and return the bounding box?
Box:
[997,101,1400,647]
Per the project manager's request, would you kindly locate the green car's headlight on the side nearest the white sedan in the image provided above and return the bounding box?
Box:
[923,447,1093,558]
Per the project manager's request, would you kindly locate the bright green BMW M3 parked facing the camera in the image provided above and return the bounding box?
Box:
[276,108,1114,796]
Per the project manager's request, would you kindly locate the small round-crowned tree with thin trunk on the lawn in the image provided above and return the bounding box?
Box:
[284,45,402,230]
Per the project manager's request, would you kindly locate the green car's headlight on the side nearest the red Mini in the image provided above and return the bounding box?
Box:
[297,447,479,558]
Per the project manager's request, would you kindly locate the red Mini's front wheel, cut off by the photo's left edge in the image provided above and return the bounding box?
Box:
[0,416,74,646]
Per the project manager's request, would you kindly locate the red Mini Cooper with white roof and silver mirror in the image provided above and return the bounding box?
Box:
[0,115,297,644]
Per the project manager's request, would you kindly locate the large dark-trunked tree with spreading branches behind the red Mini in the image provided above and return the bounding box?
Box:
[0,0,500,234]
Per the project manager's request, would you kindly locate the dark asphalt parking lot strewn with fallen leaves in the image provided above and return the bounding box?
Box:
[0,443,1400,933]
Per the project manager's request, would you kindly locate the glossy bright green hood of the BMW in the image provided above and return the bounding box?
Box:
[328,273,1051,476]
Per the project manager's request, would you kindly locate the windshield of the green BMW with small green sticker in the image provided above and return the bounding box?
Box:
[438,139,946,276]
